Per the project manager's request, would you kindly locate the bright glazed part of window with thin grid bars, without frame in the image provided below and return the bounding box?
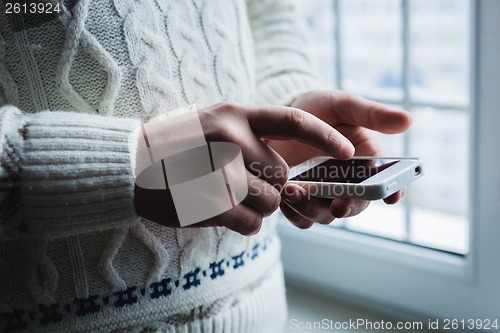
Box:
[302,0,470,255]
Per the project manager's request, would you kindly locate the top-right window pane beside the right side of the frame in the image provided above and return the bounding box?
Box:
[410,0,470,105]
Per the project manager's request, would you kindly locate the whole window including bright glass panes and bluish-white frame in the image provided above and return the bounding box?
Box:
[280,0,500,319]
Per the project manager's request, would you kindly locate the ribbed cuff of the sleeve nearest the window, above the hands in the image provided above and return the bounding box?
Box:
[257,72,324,106]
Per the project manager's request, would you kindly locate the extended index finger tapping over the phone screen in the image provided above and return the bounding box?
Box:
[245,106,354,159]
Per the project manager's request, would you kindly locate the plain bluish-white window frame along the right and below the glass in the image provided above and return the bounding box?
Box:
[279,0,500,324]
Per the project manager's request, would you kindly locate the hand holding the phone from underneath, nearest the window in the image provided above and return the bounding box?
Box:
[268,91,412,229]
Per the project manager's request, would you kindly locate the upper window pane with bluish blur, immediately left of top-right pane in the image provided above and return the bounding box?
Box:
[339,0,402,99]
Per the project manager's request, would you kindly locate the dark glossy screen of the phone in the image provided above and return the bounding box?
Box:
[290,158,399,183]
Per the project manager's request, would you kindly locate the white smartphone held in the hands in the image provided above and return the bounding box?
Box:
[288,156,424,200]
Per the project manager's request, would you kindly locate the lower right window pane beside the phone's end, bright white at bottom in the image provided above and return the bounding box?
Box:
[409,107,469,253]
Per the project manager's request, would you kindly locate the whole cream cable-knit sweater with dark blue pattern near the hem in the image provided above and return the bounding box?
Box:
[0,0,318,332]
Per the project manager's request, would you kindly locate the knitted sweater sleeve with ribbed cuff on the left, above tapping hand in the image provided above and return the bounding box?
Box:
[0,105,140,239]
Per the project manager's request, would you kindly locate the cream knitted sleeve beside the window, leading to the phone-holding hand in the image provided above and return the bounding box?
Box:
[248,0,323,105]
